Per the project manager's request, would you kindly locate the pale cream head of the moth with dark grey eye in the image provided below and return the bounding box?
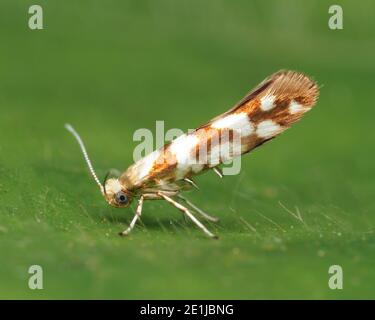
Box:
[103,178,132,208]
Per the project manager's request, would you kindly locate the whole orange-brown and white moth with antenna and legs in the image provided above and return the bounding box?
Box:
[65,70,319,238]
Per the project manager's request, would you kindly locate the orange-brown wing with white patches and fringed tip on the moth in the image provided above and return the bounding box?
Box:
[120,71,318,189]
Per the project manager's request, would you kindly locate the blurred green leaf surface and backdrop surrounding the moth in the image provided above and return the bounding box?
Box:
[0,0,375,299]
